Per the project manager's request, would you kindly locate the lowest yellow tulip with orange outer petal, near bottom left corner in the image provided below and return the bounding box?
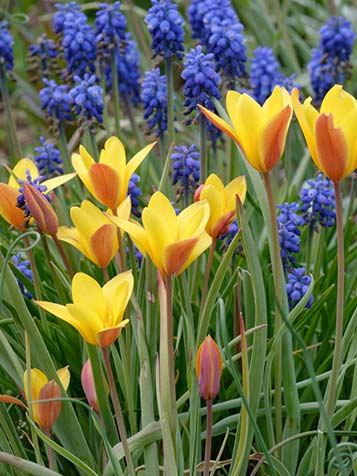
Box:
[23,367,71,430]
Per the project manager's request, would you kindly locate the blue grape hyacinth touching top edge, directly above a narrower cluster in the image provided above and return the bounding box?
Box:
[145,0,184,59]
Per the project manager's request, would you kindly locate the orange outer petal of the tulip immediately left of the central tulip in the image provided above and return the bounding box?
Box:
[90,223,119,268]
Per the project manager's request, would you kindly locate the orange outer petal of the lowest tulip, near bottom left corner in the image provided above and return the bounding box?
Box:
[34,380,61,430]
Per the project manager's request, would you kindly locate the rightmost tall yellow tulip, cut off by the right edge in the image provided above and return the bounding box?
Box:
[292,85,357,183]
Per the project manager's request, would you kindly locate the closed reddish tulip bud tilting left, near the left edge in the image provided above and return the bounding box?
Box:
[23,182,58,236]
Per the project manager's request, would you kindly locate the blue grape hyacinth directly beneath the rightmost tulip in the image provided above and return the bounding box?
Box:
[300,174,336,228]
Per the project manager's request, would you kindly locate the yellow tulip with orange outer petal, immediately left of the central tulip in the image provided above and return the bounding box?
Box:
[57,197,131,268]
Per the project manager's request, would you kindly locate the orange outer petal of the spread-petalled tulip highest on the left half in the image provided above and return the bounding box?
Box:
[89,164,123,210]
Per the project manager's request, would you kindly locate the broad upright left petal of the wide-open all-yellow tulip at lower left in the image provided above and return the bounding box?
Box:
[72,273,106,316]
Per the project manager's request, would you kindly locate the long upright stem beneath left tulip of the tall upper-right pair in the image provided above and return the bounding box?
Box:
[263,172,284,442]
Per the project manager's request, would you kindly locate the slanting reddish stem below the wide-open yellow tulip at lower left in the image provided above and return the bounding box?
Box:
[102,347,135,476]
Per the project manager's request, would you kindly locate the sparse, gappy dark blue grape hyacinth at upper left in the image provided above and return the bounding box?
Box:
[29,34,58,80]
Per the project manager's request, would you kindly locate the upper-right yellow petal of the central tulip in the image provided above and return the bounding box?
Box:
[177,200,210,240]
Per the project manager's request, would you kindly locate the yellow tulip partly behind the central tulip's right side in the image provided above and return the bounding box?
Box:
[195,174,247,239]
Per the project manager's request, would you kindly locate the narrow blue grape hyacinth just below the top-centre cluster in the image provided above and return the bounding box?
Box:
[141,68,167,136]
